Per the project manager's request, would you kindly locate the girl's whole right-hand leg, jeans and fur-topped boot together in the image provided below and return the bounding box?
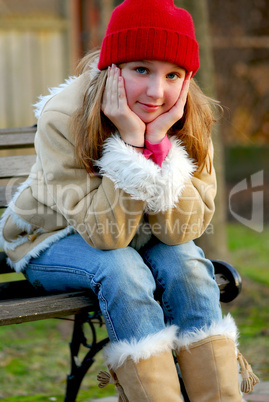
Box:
[143,242,242,402]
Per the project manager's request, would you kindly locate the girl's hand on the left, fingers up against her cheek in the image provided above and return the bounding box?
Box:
[102,65,146,146]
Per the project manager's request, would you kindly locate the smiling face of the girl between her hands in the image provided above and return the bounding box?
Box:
[119,60,186,123]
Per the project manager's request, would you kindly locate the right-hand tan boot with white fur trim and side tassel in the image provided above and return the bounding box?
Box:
[176,315,259,402]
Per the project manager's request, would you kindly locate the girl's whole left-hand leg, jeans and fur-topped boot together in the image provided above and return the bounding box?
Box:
[25,234,181,402]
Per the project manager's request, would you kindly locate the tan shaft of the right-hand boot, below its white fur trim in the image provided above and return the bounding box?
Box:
[177,335,242,402]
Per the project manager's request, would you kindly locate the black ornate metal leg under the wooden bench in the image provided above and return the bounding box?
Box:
[65,312,109,402]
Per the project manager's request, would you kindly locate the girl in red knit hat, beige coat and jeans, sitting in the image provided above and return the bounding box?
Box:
[2,0,254,402]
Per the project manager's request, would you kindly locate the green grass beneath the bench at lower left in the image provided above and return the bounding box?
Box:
[0,319,115,402]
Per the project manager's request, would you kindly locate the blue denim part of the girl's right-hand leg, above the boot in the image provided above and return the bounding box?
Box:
[142,237,222,335]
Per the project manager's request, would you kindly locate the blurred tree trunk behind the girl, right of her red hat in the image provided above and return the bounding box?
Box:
[175,0,228,259]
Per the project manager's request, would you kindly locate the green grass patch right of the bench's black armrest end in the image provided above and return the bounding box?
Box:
[223,224,269,381]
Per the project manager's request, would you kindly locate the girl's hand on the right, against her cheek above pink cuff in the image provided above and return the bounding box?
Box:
[146,72,192,144]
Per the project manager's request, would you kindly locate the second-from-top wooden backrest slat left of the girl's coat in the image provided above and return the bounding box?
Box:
[0,155,36,179]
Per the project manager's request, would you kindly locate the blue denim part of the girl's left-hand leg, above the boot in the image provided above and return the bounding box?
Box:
[24,234,165,342]
